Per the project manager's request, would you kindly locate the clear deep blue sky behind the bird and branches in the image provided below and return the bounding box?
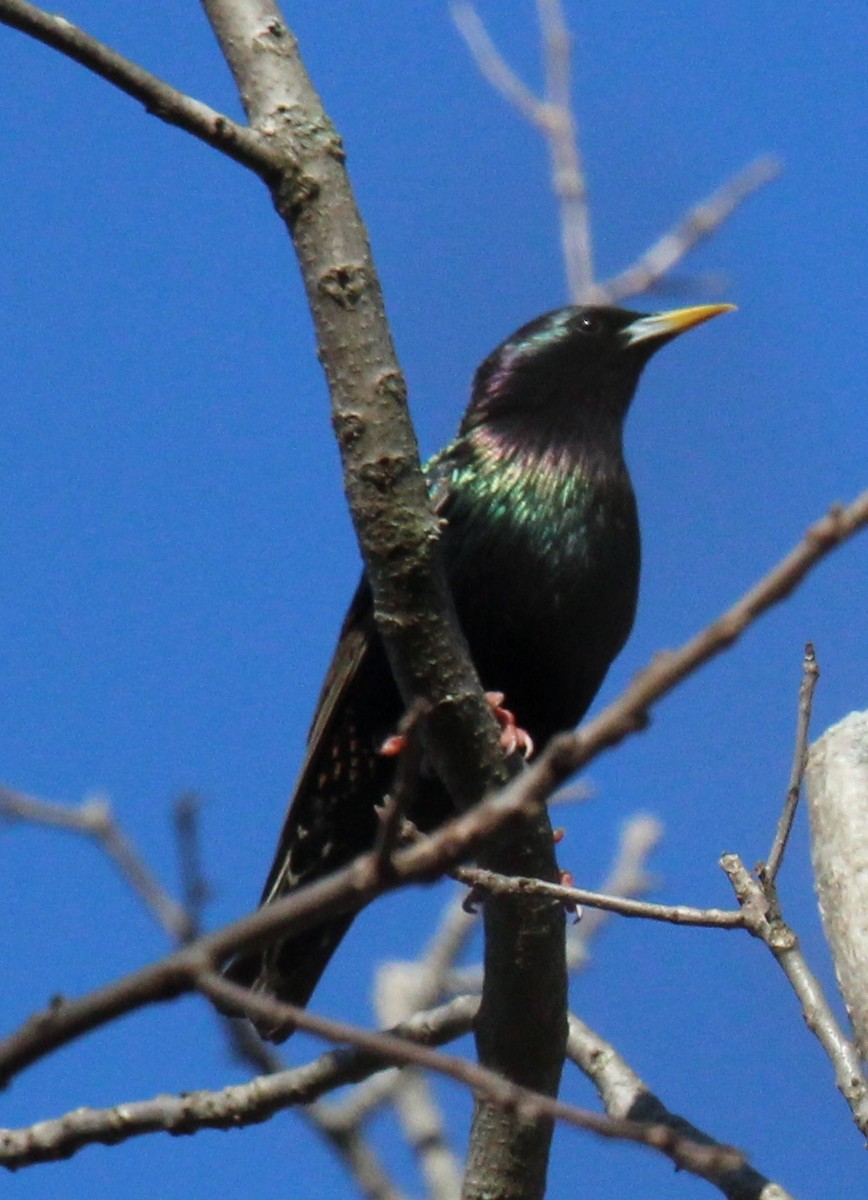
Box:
[0,0,868,1200]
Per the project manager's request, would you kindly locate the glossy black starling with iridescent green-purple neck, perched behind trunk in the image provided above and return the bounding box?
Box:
[226,297,734,1040]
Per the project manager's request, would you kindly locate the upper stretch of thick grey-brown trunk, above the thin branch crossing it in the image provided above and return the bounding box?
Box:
[195,0,505,805]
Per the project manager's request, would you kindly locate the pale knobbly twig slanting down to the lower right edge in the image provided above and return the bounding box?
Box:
[720,854,868,1134]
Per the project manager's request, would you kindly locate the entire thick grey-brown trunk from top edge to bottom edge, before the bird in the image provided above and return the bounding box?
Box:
[194,7,567,1200]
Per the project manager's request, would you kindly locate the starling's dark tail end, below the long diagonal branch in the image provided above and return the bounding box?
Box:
[223,913,355,1042]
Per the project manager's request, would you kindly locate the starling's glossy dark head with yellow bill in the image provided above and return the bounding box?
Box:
[461,304,734,438]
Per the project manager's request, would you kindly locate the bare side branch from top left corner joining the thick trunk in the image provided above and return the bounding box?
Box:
[0,0,280,180]
